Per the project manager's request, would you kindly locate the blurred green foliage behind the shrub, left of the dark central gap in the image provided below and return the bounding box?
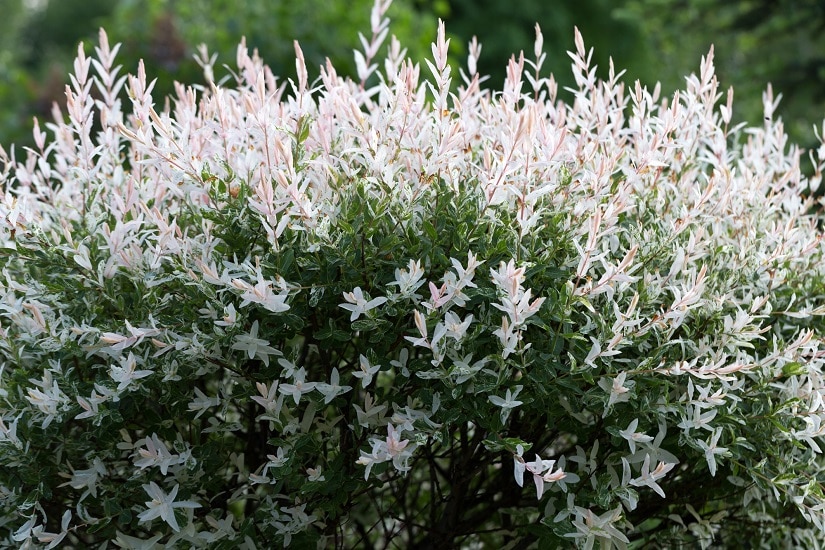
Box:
[0,0,435,150]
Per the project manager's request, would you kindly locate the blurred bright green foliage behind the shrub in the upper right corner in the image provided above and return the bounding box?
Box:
[615,0,825,152]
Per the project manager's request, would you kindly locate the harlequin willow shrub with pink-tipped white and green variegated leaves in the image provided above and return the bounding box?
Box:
[0,2,825,548]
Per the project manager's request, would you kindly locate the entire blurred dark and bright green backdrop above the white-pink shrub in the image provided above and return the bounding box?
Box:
[0,0,825,157]
